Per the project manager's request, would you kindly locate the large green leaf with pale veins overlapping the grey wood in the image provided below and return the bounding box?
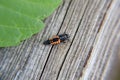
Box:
[0,0,61,47]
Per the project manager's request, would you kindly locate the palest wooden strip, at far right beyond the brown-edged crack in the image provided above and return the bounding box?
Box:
[83,0,120,80]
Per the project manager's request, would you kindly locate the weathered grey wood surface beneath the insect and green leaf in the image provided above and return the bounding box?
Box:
[0,0,120,80]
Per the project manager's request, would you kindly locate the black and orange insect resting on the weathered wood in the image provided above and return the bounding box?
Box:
[43,34,70,45]
